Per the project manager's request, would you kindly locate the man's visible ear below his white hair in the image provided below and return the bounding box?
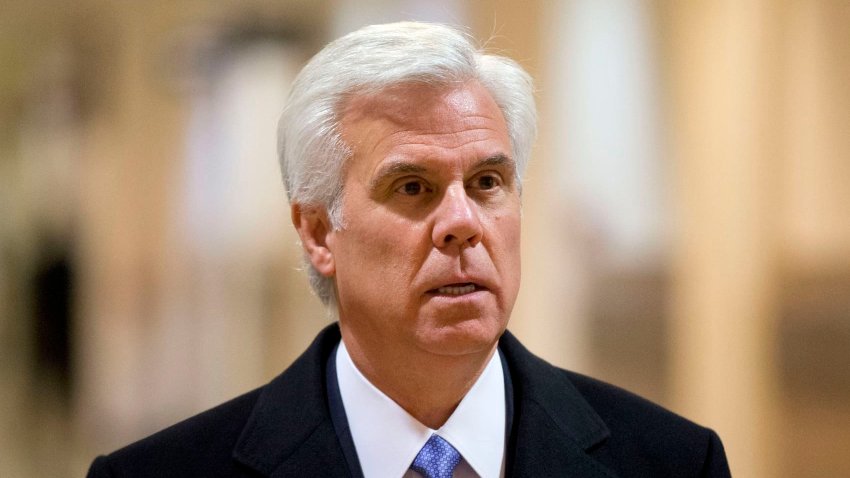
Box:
[291,204,336,277]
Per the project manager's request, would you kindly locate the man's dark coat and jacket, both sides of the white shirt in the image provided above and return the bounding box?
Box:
[89,325,729,478]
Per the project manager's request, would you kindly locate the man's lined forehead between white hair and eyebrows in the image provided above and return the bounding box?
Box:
[341,80,510,172]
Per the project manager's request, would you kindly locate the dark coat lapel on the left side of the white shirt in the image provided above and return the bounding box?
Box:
[233,324,350,477]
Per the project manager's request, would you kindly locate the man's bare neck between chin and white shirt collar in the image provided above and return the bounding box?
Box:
[342,327,496,430]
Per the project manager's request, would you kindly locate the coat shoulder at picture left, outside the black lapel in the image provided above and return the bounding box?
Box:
[89,388,262,476]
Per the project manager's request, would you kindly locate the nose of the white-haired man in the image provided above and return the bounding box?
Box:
[432,185,484,249]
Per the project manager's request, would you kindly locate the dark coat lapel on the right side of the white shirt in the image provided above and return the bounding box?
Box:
[499,332,616,478]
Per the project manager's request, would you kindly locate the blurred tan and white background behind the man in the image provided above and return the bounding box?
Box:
[0,0,850,478]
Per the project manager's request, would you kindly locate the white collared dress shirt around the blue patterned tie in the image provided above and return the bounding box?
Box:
[336,342,505,478]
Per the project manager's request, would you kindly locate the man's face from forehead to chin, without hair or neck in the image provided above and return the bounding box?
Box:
[327,81,520,355]
